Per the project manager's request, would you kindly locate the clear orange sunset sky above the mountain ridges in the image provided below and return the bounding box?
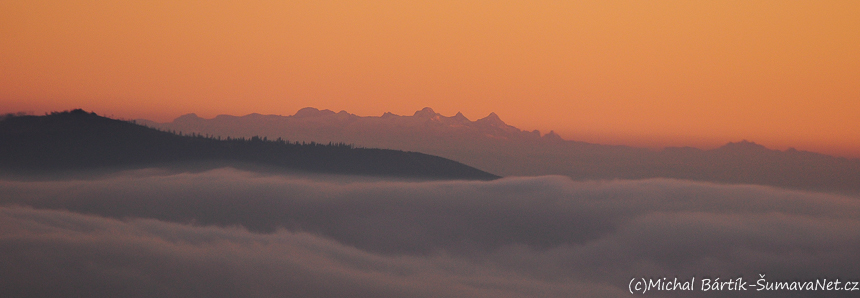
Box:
[0,0,860,157]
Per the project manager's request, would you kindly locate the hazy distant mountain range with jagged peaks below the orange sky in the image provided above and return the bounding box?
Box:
[137,108,860,194]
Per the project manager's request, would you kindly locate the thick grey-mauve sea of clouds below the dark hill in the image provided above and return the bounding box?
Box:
[0,168,860,297]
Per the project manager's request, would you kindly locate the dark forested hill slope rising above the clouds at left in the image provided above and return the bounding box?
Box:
[0,110,498,179]
